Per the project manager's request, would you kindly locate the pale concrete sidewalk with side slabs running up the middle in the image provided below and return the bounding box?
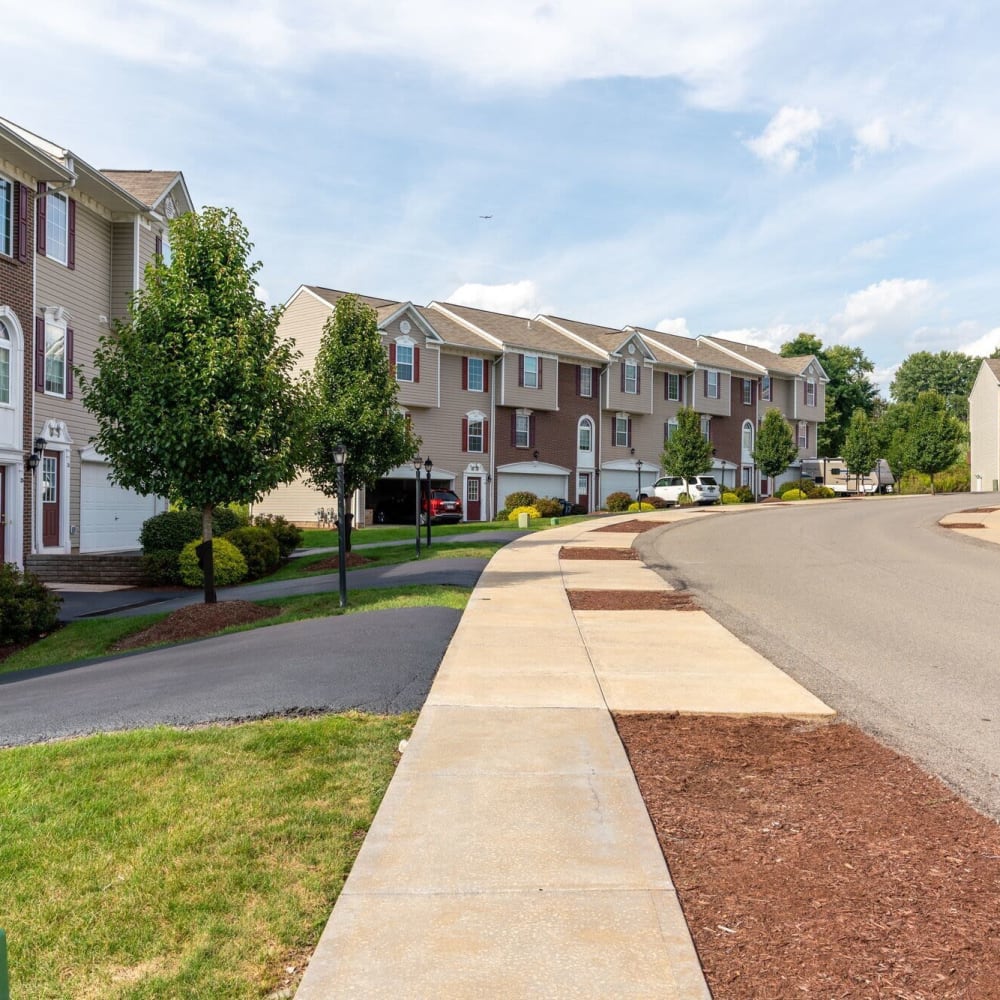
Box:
[297,513,833,1000]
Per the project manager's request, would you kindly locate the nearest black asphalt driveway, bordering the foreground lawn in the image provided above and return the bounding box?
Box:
[0,607,461,746]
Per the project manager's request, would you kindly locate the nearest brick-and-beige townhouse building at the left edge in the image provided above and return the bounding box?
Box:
[0,119,193,563]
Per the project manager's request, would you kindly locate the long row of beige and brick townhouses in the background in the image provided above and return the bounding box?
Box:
[256,286,826,524]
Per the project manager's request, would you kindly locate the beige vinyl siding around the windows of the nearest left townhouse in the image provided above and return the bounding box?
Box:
[32,196,112,549]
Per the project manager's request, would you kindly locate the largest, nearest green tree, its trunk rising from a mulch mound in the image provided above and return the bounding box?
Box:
[78,208,305,603]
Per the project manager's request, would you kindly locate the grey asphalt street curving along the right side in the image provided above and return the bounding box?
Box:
[636,494,1000,818]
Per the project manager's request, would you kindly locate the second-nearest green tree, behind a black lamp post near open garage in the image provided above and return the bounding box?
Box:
[305,295,420,550]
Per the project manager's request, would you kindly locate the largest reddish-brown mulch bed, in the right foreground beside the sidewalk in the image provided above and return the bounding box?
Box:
[616,715,1000,1000]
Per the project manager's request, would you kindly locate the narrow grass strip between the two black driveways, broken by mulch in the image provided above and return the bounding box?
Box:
[0,585,470,674]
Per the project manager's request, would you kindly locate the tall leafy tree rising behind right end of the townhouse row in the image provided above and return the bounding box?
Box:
[781,333,878,457]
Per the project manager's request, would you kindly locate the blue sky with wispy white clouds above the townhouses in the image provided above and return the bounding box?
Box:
[7,0,1000,387]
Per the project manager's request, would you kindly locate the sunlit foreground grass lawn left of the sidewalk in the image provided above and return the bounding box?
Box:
[0,714,415,1000]
